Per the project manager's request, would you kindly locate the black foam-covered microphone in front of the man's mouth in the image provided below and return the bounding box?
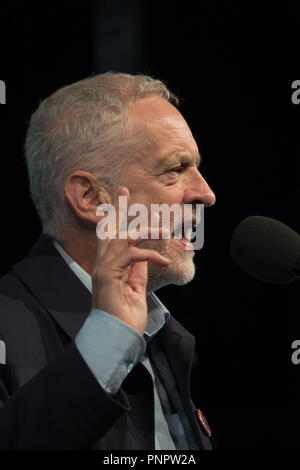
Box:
[230,215,300,283]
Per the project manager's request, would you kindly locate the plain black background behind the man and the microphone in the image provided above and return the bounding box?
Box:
[0,0,300,449]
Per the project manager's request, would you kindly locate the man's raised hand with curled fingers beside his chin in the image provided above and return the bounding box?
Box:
[92,187,170,334]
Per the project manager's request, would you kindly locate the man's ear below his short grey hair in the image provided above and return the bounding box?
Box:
[64,170,111,225]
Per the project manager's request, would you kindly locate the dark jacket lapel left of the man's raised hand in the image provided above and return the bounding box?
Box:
[12,234,91,339]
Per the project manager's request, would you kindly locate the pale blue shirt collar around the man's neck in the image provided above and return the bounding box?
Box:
[52,240,170,342]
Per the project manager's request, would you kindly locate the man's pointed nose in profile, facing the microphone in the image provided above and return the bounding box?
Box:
[183,169,216,207]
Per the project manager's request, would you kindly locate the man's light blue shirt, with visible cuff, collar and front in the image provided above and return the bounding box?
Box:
[52,240,183,450]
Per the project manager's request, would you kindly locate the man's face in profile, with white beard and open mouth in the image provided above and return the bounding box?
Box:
[122,96,215,291]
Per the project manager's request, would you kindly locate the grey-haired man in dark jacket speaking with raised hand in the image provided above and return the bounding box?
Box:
[0,73,215,450]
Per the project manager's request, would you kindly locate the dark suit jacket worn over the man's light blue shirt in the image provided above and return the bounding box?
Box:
[0,235,211,450]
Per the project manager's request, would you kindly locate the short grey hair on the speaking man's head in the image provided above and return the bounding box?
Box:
[25,72,178,241]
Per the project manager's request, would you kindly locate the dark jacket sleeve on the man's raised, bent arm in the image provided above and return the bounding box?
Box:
[0,338,130,450]
